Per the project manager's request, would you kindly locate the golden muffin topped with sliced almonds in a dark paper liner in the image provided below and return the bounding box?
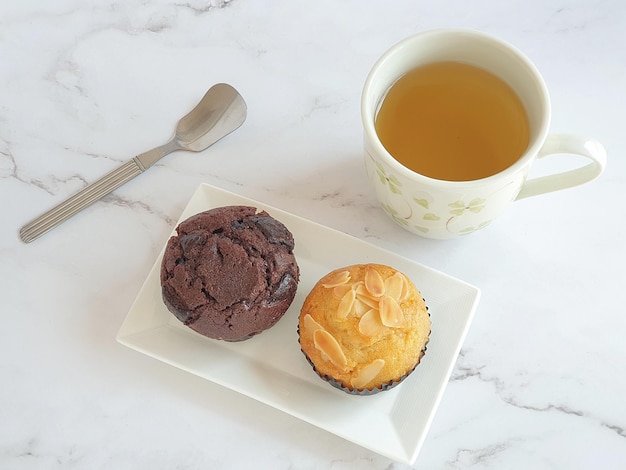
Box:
[298,264,430,395]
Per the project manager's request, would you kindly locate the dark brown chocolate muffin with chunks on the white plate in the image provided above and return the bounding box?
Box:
[161,206,300,341]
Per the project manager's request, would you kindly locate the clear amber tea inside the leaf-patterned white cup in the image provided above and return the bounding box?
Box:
[376,62,529,181]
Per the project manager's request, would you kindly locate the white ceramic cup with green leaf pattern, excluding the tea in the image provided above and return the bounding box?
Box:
[361,29,606,239]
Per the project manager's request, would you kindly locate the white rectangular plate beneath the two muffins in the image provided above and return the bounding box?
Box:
[117,185,480,464]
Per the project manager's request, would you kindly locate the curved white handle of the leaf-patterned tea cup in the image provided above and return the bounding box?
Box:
[516,134,606,200]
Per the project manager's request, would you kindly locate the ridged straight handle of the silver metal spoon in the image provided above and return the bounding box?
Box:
[20,157,145,243]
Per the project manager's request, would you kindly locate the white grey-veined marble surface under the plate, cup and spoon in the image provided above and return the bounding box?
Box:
[0,0,626,470]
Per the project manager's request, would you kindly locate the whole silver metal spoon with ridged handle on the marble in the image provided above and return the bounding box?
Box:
[20,83,247,243]
